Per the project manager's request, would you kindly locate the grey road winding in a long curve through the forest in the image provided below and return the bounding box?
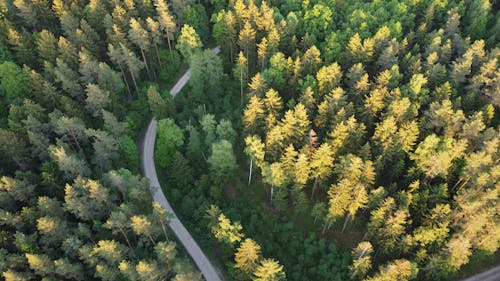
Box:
[141,47,222,281]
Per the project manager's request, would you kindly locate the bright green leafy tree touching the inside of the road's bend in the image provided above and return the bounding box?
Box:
[155,119,184,168]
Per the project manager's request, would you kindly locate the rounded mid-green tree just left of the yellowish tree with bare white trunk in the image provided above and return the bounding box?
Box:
[207,139,236,184]
